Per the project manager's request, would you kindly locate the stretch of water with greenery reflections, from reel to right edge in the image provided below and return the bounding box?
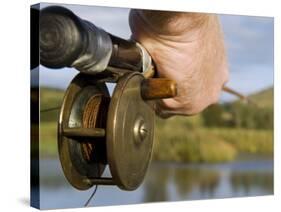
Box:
[140,161,273,202]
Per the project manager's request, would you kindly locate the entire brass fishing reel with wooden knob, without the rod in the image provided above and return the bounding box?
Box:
[58,72,175,190]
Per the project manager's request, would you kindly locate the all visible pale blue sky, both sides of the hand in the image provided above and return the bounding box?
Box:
[37,4,274,101]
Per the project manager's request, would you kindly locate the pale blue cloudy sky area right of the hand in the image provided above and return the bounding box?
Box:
[220,15,274,100]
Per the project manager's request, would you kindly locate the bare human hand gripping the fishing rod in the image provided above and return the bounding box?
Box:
[129,10,228,117]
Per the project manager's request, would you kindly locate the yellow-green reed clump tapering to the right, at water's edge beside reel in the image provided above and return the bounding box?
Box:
[154,125,237,162]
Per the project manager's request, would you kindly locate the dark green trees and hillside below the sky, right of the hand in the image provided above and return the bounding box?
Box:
[201,88,273,129]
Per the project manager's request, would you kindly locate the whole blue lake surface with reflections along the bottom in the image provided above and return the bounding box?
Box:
[40,158,273,209]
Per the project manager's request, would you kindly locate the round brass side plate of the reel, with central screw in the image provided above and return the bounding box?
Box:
[106,72,154,190]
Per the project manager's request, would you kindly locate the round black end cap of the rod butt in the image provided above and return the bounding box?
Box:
[40,6,86,68]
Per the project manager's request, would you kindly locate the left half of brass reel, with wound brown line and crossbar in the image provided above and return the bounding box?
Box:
[58,74,110,190]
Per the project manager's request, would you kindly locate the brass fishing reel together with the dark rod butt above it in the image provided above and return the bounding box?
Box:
[40,6,177,190]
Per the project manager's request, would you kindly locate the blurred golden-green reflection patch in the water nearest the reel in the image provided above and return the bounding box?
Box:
[143,166,220,202]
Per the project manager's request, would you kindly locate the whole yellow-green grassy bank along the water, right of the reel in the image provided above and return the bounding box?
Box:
[154,117,273,162]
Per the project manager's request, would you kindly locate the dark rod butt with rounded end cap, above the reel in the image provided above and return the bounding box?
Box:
[40,6,144,74]
